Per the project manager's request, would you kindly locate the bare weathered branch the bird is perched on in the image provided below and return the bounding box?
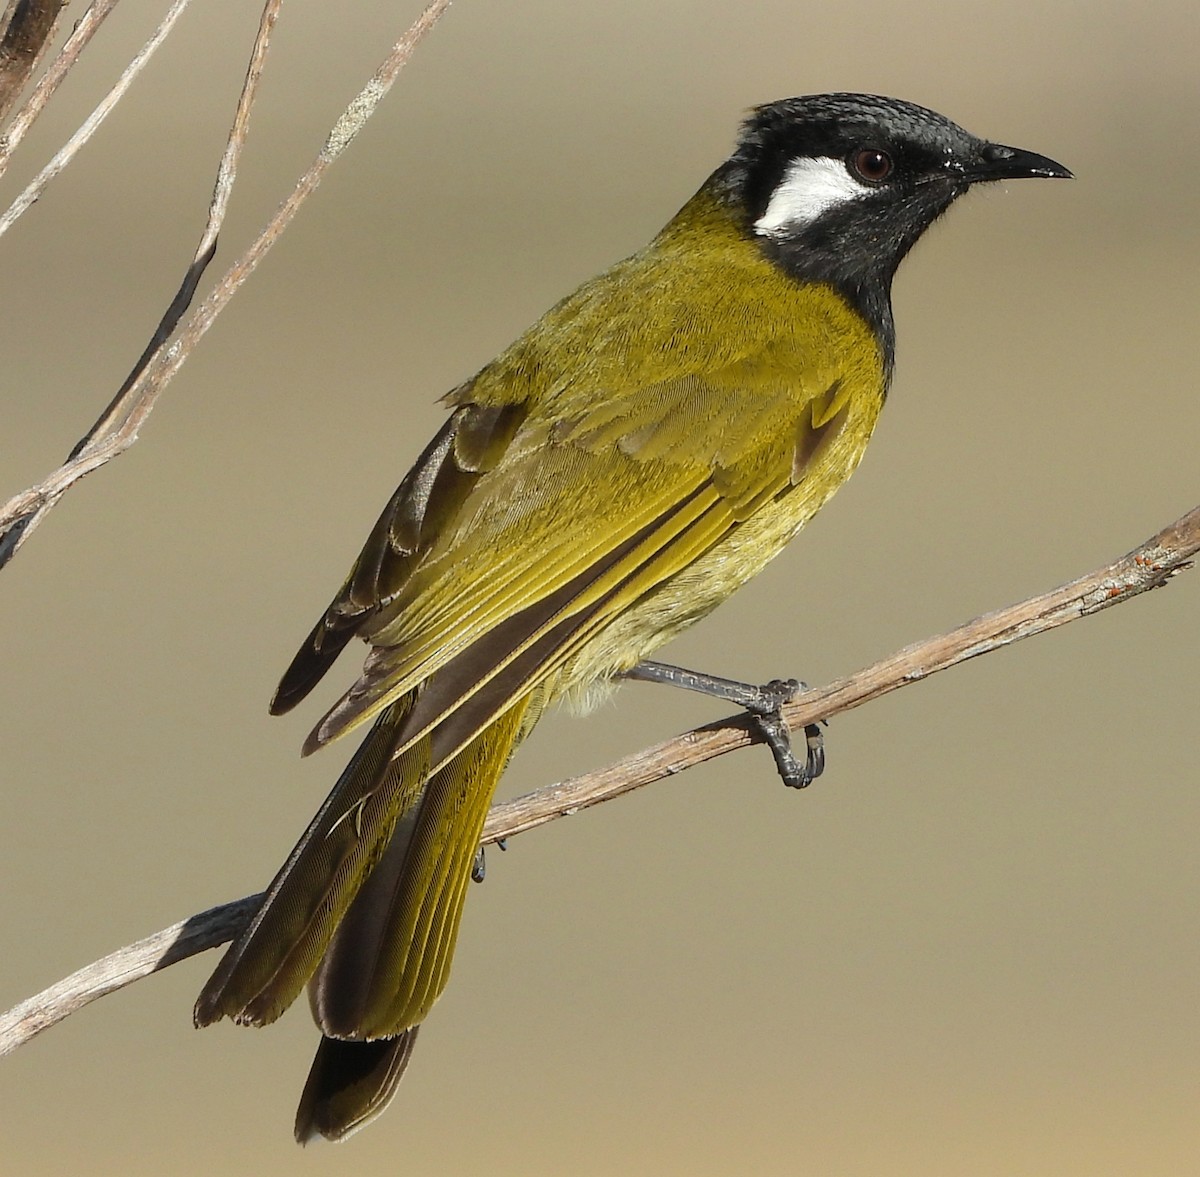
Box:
[0,506,1200,1055]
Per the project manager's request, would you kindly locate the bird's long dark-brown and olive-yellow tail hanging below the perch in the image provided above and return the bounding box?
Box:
[194,696,529,1142]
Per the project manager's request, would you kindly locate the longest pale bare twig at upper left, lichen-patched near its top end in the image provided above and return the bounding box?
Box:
[0,0,450,568]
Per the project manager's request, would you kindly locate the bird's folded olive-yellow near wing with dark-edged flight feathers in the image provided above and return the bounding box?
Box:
[308,345,845,752]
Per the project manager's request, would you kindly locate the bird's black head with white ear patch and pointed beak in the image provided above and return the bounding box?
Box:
[722,94,1070,350]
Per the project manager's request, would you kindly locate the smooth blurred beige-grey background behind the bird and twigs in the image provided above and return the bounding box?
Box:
[0,0,1200,1177]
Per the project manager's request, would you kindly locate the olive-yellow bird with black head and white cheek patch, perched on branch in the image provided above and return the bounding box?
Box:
[194,94,1070,1143]
